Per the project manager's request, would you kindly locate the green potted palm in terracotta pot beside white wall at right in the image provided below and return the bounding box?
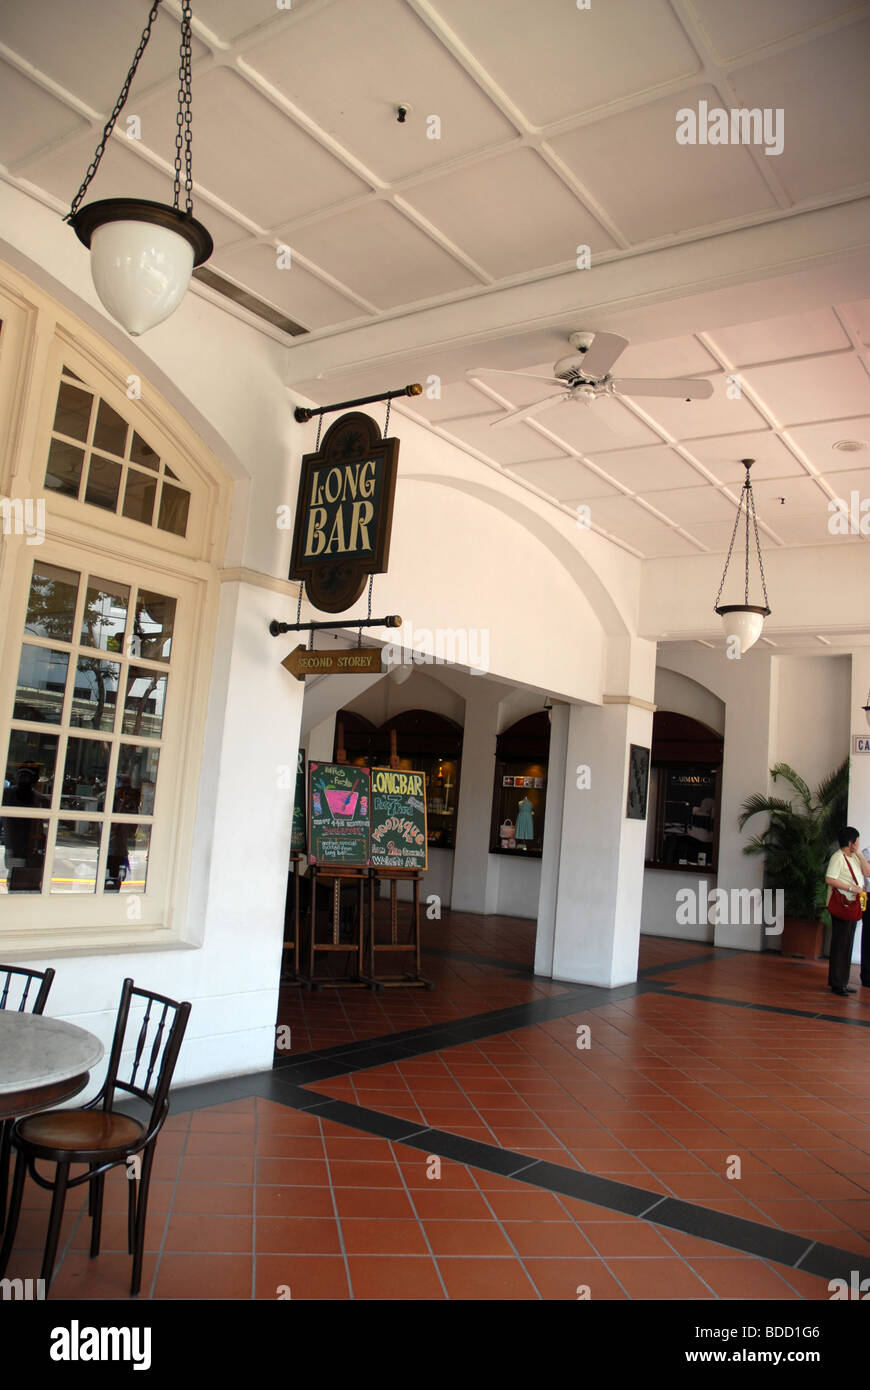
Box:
[738,759,849,960]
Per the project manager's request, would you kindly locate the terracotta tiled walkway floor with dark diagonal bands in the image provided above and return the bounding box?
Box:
[8,915,870,1300]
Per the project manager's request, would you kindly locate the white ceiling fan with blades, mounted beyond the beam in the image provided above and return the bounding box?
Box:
[466,332,713,430]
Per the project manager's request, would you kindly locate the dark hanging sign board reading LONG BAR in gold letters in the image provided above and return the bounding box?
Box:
[289,410,399,613]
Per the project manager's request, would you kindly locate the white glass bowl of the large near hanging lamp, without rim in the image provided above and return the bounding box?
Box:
[90,222,193,338]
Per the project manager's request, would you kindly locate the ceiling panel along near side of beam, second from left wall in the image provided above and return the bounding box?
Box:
[289,202,479,309]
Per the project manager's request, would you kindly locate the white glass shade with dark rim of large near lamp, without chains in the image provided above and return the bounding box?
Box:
[72,197,213,338]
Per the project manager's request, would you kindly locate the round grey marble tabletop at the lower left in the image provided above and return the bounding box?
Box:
[0,1009,103,1120]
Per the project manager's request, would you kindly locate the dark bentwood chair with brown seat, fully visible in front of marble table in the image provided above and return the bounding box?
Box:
[0,979,190,1297]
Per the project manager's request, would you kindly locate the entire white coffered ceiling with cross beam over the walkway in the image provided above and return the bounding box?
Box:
[0,0,870,557]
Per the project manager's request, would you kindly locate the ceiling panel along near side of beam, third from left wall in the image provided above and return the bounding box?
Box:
[403,150,614,277]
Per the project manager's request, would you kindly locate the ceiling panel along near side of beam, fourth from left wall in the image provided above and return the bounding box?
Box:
[549,86,775,242]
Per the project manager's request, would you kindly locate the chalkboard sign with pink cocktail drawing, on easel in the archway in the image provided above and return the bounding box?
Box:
[309,763,371,869]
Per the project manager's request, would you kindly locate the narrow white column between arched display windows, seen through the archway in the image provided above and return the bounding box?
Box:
[450,682,502,913]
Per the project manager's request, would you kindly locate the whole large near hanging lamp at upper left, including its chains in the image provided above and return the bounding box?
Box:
[64,0,214,336]
